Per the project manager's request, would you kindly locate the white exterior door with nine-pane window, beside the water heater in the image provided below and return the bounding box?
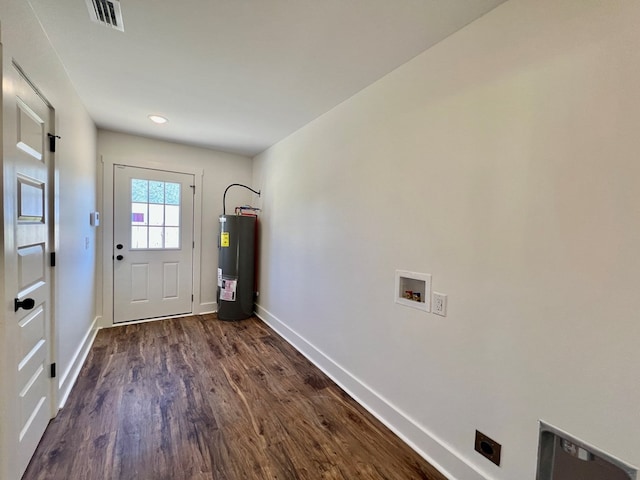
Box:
[113,165,194,322]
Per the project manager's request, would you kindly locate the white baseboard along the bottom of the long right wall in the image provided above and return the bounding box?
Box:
[256,304,487,480]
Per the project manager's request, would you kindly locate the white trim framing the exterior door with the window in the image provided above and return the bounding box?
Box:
[97,155,202,328]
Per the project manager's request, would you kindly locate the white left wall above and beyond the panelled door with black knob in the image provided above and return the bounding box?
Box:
[0,0,97,476]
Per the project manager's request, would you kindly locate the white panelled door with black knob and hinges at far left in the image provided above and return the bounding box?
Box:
[0,63,56,479]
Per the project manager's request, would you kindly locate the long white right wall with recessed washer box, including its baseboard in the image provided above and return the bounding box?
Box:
[254,0,640,480]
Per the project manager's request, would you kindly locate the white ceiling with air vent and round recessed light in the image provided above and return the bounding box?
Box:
[30,0,505,156]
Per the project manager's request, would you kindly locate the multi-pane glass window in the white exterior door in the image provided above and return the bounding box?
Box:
[131,178,180,250]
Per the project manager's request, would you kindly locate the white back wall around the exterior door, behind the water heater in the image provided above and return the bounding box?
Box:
[98,126,255,325]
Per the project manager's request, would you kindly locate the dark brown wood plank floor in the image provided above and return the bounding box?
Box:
[23,315,446,480]
